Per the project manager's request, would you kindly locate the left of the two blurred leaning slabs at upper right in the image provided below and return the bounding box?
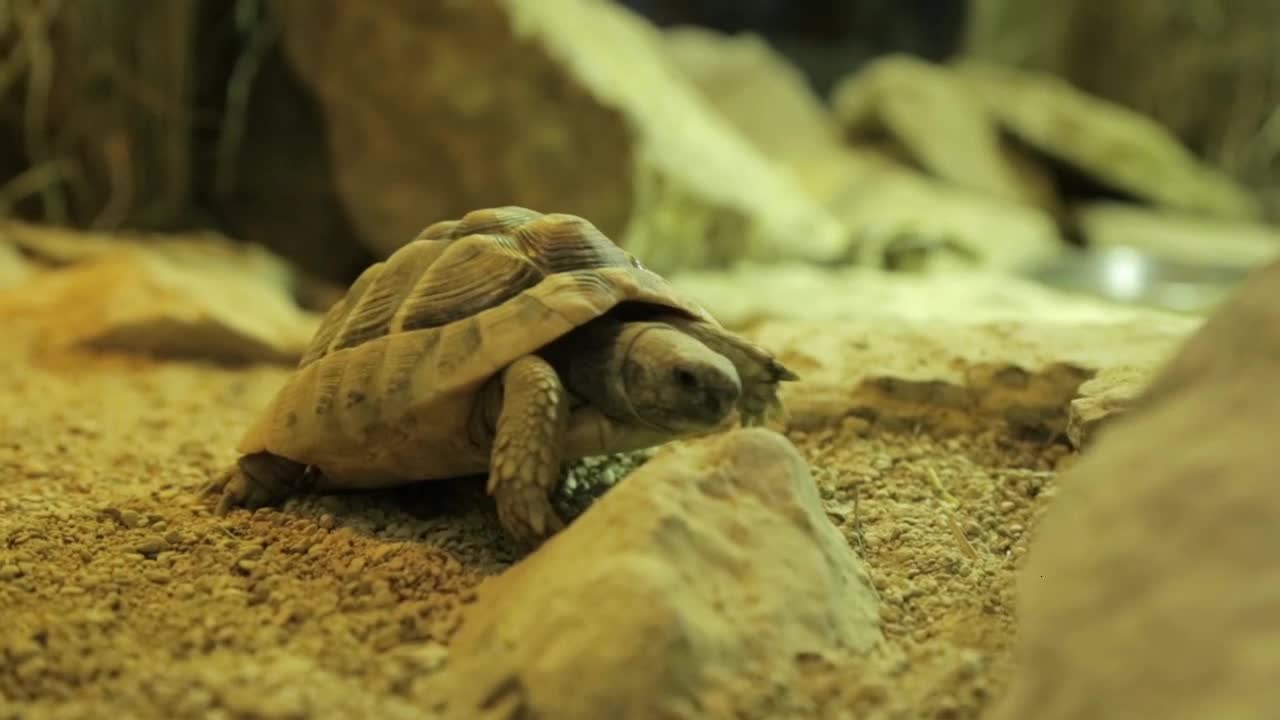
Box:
[832,54,1059,211]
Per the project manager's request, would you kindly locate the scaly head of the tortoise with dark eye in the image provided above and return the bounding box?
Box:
[614,323,742,434]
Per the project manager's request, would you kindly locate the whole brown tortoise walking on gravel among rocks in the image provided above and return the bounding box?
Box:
[206,206,799,546]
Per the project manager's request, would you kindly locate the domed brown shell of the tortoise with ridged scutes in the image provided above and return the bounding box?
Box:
[239,208,717,488]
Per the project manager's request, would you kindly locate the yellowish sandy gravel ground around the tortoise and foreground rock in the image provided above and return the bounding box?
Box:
[0,319,1070,719]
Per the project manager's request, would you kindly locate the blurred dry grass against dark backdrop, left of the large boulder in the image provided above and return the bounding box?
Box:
[0,0,275,229]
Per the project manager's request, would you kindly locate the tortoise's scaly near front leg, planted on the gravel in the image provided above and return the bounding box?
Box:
[486,355,570,547]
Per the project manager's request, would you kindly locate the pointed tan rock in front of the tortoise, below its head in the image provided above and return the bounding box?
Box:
[433,428,881,720]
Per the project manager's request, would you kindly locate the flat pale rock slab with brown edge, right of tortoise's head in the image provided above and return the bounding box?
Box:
[673,260,1201,437]
